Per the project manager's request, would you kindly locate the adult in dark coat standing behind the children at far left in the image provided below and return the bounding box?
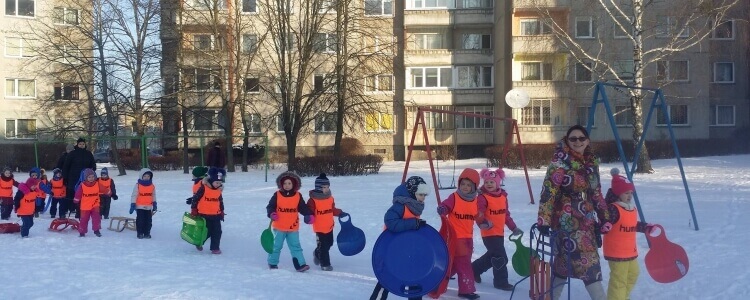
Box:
[62,138,96,218]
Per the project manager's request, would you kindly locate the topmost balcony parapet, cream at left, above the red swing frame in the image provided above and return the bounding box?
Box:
[404,9,495,27]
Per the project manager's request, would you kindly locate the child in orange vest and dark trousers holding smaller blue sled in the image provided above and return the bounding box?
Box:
[307,173,345,271]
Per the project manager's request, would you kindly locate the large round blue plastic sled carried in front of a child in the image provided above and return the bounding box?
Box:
[372,225,448,298]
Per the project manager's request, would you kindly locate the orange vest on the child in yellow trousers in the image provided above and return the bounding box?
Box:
[603,204,638,258]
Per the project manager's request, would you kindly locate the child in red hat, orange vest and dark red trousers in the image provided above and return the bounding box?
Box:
[437,168,489,299]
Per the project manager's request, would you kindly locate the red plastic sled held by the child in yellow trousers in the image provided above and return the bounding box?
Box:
[644,225,690,283]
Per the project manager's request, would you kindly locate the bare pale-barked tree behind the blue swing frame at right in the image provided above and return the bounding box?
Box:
[529,0,739,173]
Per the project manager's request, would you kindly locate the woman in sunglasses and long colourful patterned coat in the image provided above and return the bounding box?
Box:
[537,125,608,300]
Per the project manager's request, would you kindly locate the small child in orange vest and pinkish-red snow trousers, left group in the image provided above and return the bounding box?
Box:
[73,168,102,237]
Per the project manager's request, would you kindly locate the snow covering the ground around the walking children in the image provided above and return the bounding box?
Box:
[0,155,750,299]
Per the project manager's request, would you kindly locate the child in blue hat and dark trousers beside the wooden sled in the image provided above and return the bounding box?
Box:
[130,168,156,239]
